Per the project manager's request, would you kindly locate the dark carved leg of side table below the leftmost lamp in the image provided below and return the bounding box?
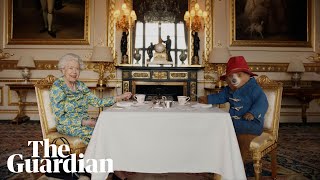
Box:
[12,90,30,124]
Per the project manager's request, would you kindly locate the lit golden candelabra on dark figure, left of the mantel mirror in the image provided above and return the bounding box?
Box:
[113,3,137,64]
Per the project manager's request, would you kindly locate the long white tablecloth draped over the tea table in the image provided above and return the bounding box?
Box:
[85,104,246,180]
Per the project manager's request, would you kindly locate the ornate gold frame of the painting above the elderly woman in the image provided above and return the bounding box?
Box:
[7,0,90,45]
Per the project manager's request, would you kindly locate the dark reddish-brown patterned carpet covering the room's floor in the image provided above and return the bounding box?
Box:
[0,121,320,180]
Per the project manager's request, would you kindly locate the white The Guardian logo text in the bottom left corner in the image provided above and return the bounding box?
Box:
[7,139,113,173]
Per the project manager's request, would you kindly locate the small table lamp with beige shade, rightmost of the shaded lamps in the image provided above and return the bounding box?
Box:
[287,60,305,89]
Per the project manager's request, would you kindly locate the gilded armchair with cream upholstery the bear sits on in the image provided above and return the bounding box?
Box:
[250,75,282,179]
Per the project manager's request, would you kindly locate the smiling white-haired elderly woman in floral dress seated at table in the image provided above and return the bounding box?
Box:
[50,53,131,179]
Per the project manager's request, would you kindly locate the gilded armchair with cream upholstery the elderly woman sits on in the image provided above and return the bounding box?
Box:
[35,75,87,154]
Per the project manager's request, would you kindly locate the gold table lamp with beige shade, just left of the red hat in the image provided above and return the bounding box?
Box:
[208,44,231,88]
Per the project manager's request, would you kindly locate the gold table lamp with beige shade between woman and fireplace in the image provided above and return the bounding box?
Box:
[91,46,113,87]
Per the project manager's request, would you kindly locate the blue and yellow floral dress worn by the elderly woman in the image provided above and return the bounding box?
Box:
[50,77,116,144]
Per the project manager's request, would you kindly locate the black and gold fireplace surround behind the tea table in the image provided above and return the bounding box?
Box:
[117,66,202,101]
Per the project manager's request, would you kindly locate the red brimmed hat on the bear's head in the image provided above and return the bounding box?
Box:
[220,56,257,81]
